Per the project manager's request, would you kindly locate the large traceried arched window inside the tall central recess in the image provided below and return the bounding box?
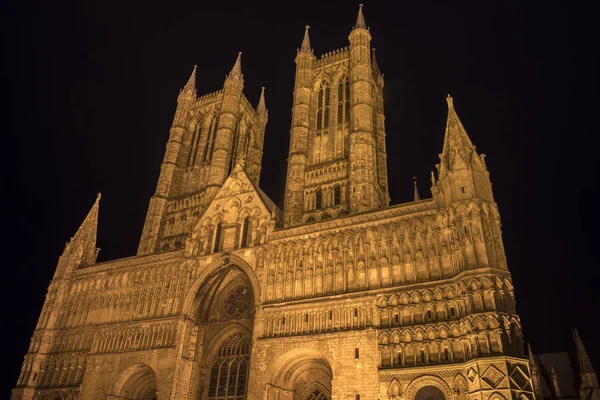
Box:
[208,333,250,400]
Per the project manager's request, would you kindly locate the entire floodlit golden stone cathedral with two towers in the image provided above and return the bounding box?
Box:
[12,6,600,400]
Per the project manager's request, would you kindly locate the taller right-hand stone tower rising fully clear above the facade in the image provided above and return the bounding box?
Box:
[284,6,389,227]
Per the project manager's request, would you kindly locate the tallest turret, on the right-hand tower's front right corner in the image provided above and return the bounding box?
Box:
[348,4,380,212]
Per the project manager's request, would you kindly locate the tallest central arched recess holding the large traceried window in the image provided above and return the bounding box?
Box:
[191,264,256,400]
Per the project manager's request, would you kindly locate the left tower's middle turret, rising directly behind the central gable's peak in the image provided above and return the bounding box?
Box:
[206,52,244,198]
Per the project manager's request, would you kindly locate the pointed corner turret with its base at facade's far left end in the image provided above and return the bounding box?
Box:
[54,193,100,279]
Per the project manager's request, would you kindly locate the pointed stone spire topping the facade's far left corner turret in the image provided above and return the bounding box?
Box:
[63,193,101,265]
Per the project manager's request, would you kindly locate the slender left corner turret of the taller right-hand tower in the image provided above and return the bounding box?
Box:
[284,25,316,227]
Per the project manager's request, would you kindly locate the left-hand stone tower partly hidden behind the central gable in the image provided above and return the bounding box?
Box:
[138,53,267,255]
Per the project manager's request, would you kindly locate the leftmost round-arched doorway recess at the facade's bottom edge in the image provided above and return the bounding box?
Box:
[108,364,157,400]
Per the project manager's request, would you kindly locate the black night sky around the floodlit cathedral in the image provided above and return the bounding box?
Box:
[0,0,600,393]
